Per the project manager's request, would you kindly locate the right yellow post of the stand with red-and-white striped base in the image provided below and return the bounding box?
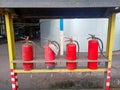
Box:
[104,13,116,90]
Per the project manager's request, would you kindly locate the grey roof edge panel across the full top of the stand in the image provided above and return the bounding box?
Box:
[0,0,120,8]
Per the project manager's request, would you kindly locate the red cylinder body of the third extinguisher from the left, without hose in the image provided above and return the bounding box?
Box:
[66,43,77,70]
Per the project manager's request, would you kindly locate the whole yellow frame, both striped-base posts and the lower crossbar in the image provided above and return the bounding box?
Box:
[0,10,116,90]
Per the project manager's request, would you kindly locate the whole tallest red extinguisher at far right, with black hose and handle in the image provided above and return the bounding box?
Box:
[88,34,103,69]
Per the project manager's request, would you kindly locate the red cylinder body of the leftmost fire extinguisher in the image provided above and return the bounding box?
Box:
[22,44,34,70]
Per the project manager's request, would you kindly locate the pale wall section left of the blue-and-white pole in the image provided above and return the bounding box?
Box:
[40,19,59,46]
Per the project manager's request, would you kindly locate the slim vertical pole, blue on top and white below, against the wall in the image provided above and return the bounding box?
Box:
[60,19,64,55]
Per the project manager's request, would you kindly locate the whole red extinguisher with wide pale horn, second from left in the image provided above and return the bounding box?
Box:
[44,40,60,69]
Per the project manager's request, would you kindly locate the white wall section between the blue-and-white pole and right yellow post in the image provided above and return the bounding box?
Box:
[65,19,108,52]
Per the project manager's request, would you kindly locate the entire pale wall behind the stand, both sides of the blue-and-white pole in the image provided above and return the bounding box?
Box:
[40,15,120,52]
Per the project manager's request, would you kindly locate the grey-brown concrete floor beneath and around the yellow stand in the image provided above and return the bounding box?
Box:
[0,42,120,90]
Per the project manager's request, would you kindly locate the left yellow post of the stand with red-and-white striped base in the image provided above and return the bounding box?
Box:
[5,12,18,90]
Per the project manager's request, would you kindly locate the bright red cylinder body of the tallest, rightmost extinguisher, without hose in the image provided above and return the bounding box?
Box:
[88,40,98,69]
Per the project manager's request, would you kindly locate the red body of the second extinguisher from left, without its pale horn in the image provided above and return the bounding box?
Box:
[44,44,55,66]
